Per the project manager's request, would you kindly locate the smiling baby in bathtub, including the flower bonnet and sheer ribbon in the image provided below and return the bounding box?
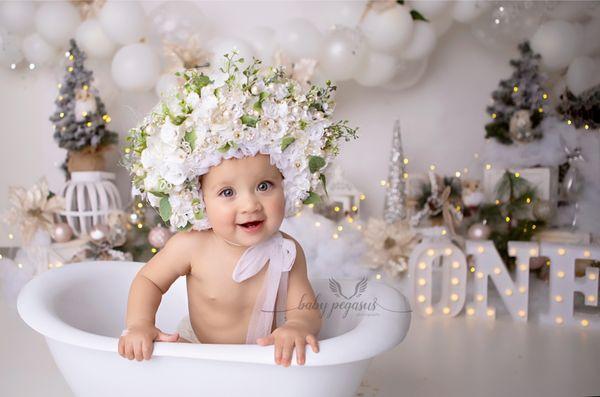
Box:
[119,52,356,367]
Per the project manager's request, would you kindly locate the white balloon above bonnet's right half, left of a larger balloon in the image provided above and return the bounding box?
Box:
[277,18,322,59]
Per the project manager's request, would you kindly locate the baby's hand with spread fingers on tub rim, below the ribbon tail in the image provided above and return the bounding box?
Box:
[256,321,319,367]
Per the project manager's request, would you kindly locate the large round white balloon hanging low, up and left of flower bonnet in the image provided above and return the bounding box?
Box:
[111,43,160,92]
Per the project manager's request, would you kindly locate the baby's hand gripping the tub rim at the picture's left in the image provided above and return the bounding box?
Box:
[119,325,179,361]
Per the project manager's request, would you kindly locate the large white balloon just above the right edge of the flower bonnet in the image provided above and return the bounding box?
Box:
[319,26,368,81]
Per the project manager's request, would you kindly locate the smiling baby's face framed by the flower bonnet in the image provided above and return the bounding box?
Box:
[201,154,285,246]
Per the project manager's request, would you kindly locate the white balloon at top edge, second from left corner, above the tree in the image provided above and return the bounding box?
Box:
[35,2,81,47]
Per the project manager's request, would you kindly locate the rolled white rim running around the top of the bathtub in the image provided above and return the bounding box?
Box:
[17,261,411,366]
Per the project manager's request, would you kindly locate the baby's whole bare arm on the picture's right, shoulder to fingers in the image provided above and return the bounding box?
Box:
[257,233,321,367]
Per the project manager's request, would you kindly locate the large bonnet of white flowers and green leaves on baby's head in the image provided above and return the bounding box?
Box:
[122,51,356,231]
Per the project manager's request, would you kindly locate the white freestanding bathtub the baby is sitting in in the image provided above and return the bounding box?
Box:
[17,262,410,397]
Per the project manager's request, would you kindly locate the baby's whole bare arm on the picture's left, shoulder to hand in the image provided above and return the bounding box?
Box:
[119,233,193,361]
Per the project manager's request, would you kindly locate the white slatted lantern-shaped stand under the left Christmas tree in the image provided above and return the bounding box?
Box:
[61,171,121,236]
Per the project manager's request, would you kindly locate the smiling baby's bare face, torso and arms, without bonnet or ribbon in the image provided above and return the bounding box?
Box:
[119,154,321,367]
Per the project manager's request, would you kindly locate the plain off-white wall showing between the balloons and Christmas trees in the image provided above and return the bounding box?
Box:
[0,1,518,245]
